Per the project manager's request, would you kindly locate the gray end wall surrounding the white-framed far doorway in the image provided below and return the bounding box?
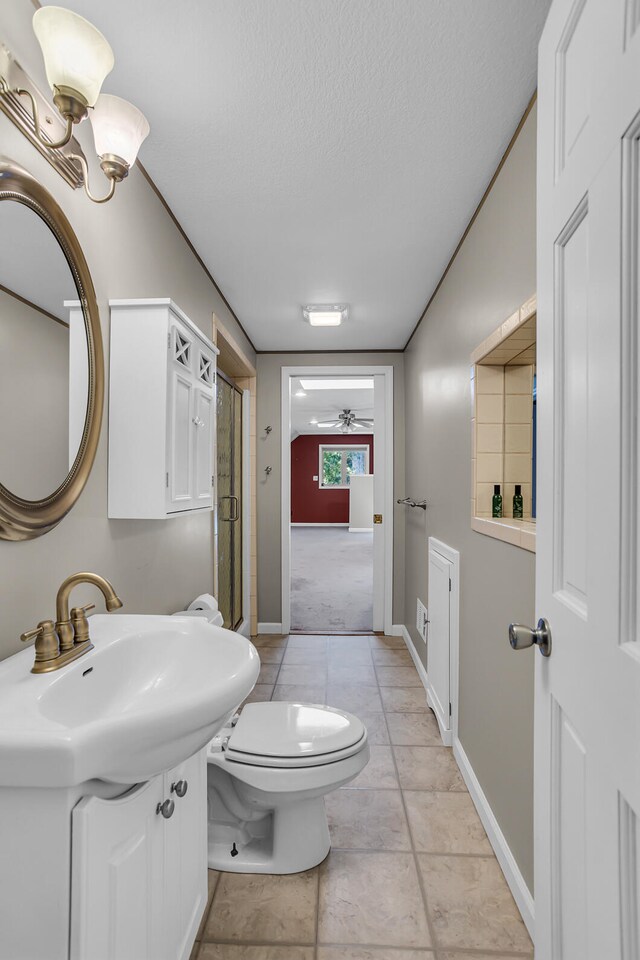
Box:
[257,353,404,623]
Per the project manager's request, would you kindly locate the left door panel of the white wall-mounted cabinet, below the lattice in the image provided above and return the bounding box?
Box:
[167,368,195,513]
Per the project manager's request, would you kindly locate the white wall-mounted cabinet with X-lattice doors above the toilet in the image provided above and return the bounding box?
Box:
[109,299,218,520]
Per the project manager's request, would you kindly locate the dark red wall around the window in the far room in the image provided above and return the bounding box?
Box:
[291,433,373,523]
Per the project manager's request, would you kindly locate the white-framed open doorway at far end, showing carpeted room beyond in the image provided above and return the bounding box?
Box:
[281,366,393,634]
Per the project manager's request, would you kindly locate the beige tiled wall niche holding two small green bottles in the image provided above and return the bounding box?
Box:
[471,297,536,551]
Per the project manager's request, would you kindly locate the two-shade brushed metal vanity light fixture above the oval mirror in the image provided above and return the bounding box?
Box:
[0,7,149,203]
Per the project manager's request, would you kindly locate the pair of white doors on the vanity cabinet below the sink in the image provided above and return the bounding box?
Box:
[70,751,207,960]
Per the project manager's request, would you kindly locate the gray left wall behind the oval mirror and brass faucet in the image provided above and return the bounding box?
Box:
[0,0,255,657]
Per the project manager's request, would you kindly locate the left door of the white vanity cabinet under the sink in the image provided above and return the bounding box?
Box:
[70,777,166,960]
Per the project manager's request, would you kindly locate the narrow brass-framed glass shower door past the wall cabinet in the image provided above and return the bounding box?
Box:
[216,372,242,630]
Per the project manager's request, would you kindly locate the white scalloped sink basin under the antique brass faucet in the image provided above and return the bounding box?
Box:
[0,614,260,787]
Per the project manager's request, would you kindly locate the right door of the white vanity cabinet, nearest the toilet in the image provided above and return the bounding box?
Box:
[164,750,207,960]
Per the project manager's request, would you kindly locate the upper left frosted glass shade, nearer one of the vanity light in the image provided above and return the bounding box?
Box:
[33,7,115,107]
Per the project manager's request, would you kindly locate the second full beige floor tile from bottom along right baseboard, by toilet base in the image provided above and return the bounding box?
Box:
[404,790,493,856]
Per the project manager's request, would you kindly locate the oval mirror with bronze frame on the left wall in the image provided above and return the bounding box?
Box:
[0,160,104,540]
